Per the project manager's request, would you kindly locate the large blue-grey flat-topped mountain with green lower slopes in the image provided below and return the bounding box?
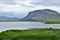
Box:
[22,9,60,22]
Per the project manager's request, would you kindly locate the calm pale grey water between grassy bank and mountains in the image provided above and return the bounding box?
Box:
[0,22,60,31]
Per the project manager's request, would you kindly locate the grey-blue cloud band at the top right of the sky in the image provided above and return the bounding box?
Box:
[31,0,60,6]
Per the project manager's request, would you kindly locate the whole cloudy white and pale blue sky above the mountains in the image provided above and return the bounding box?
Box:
[0,0,60,18]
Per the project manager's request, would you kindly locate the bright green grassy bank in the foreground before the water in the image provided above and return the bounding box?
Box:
[0,28,60,40]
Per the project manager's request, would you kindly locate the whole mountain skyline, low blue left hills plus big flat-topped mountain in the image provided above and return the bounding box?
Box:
[0,9,60,22]
